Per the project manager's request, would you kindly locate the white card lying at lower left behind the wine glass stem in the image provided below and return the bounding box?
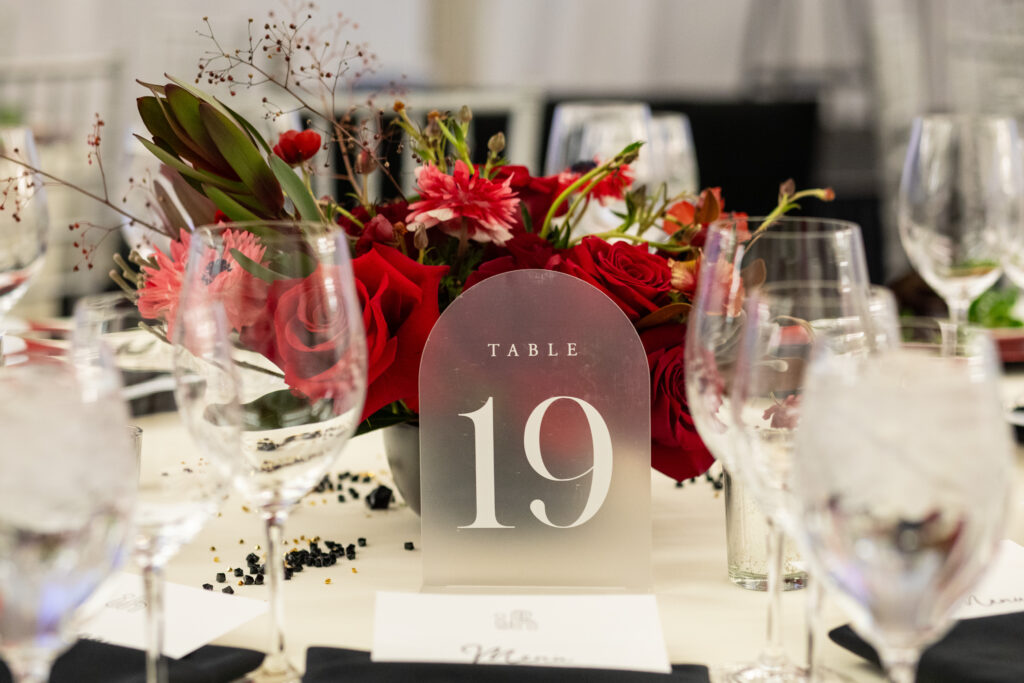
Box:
[79,572,267,659]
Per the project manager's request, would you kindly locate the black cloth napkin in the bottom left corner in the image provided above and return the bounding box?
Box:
[0,640,263,683]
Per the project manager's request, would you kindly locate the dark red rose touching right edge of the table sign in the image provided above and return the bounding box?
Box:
[640,324,715,481]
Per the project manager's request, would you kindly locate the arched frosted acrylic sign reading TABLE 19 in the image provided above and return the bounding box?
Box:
[420,270,651,592]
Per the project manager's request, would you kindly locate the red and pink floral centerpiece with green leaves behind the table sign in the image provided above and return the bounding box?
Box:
[0,9,830,480]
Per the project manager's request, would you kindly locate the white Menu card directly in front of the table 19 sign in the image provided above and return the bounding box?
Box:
[372,592,672,674]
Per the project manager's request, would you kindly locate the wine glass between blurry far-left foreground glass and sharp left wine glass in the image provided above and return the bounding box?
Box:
[73,293,227,683]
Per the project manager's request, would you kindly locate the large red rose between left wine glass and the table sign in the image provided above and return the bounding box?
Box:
[352,244,449,420]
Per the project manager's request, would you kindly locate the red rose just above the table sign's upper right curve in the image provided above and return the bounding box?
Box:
[548,237,672,322]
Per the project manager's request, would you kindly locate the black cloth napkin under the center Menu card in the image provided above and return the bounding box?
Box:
[302,647,711,683]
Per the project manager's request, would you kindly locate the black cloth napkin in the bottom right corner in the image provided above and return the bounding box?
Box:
[828,612,1024,683]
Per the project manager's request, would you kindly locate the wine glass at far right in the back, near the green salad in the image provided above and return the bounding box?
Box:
[899,115,1024,324]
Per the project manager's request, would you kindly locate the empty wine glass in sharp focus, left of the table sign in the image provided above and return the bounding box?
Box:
[171,222,367,682]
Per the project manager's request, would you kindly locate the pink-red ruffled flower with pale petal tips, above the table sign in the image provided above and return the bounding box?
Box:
[406,161,519,246]
